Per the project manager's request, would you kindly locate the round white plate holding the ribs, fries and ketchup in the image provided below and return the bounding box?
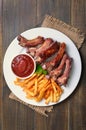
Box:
[3,27,82,106]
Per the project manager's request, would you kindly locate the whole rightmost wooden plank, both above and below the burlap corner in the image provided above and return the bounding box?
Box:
[69,0,86,130]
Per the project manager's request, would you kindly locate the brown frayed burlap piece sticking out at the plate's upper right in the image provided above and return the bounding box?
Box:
[42,15,85,49]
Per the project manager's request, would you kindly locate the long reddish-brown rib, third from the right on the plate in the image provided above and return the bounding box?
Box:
[42,43,66,72]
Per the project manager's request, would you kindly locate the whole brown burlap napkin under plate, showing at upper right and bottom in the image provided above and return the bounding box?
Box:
[9,15,85,116]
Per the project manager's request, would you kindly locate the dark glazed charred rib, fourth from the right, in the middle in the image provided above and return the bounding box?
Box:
[36,42,59,63]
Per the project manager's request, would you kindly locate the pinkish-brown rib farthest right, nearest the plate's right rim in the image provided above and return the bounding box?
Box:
[57,58,72,85]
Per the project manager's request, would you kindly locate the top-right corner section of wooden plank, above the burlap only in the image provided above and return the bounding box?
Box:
[71,0,86,33]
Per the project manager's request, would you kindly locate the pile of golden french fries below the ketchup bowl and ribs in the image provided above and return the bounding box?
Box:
[14,73,63,104]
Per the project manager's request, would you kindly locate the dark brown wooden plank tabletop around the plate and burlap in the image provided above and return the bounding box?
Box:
[0,0,86,130]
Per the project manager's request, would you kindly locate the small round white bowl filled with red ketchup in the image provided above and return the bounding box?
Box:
[11,54,36,78]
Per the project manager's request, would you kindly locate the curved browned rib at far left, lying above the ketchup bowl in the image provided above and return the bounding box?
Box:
[17,35,44,47]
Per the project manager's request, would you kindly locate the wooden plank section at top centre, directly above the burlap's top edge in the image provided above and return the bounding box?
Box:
[37,0,71,23]
